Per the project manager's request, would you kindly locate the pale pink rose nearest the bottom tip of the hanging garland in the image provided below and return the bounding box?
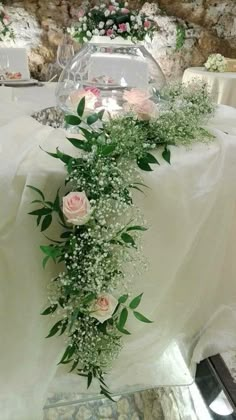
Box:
[91,293,118,323]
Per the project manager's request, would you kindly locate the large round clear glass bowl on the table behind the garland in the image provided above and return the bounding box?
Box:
[56,37,166,114]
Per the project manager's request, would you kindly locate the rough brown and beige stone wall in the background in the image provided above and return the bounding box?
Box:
[0,0,236,79]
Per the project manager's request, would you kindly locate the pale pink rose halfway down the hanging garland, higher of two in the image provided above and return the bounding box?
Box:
[63,191,91,226]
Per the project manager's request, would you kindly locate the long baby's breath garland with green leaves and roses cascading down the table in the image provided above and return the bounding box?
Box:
[28,86,214,398]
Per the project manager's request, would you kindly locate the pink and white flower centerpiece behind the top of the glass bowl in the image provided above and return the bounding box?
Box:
[68,0,157,43]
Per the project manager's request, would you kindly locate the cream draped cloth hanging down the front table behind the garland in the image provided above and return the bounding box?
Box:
[0,84,236,420]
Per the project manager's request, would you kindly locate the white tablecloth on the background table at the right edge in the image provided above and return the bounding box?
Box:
[183,67,236,107]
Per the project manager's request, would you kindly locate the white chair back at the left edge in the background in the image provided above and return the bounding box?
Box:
[0,48,30,80]
